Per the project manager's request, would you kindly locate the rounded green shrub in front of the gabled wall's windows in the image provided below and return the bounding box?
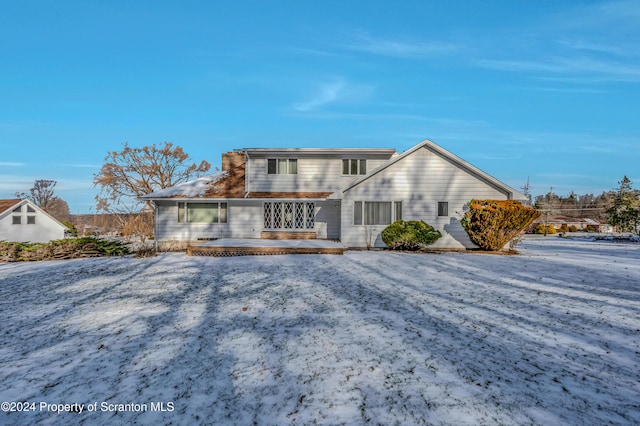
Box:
[382,220,442,251]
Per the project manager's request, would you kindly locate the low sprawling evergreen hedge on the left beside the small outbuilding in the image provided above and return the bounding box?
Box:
[0,237,129,262]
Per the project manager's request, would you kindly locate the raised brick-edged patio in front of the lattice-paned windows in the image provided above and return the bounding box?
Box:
[187,238,346,256]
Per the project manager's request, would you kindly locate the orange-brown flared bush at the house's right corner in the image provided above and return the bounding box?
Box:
[461,200,540,251]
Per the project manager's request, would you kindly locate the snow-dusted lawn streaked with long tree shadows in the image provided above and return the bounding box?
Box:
[0,237,640,425]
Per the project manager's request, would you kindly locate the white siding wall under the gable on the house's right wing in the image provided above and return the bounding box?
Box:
[341,148,507,248]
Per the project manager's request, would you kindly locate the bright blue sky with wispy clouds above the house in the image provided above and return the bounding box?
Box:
[0,0,640,213]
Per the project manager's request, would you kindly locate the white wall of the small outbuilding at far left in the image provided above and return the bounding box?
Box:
[0,204,66,243]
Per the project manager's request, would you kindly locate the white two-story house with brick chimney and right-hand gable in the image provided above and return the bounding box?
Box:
[143,140,526,248]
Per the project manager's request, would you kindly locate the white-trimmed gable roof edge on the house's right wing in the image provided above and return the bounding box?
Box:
[330,139,527,201]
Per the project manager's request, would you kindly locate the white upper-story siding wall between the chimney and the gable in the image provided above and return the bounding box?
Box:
[248,153,389,192]
